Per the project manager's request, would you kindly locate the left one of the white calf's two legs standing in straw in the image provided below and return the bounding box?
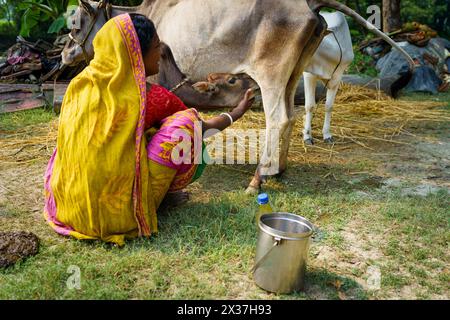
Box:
[303,72,317,145]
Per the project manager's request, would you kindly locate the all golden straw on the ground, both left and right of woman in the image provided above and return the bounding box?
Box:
[0,84,450,165]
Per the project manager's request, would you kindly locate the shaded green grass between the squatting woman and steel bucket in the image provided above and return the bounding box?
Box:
[128,198,257,258]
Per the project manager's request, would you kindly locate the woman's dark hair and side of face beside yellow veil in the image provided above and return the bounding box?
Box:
[130,13,161,76]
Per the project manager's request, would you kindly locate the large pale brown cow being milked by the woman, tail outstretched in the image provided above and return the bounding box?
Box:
[63,0,414,192]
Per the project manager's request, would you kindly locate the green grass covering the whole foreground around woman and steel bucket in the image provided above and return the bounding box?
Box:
[0,94,450,299]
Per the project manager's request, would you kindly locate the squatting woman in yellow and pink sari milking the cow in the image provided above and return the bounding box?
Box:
[44,14,255,245]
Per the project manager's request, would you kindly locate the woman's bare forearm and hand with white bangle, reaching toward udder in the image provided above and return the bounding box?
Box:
[202,89,255,138]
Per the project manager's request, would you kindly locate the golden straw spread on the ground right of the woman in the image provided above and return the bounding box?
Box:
[206,84,450,163]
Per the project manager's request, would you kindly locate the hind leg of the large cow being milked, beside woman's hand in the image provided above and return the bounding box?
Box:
[246,6,326,193]
